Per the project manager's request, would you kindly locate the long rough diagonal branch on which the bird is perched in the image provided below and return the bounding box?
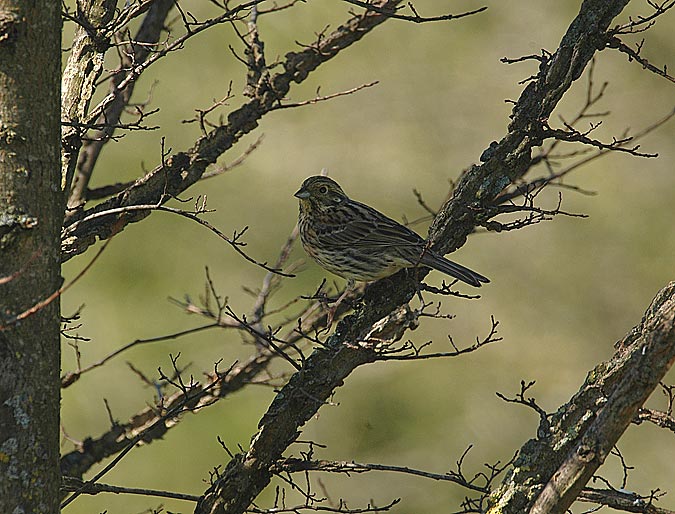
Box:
[195,0,628,514]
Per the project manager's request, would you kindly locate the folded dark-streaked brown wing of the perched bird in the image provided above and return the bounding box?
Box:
[315,200,424,249]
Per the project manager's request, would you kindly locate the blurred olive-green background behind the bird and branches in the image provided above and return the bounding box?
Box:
[62,0,675,514]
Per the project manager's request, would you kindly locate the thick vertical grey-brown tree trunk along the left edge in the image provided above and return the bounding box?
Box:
[0,0,64,514]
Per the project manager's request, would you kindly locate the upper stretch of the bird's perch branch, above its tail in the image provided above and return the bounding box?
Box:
[429,0,629,253]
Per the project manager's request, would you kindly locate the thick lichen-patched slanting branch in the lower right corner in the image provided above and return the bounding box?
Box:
[488,282,675,514]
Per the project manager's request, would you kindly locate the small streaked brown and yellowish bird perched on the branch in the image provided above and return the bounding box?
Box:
[295,175,489,287]
